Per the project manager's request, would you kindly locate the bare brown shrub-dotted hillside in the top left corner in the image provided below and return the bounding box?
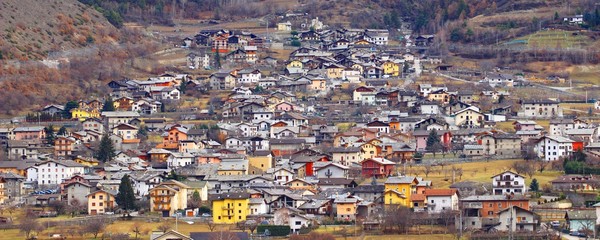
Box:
[0,0,120,60]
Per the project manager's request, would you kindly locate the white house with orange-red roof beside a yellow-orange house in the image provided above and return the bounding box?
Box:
[423,189,459,213]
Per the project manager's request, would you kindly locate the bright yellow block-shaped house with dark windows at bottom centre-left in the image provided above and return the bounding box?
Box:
[210,192,250,224]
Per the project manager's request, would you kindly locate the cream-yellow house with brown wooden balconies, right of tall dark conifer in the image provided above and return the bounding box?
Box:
[149,180,190,217]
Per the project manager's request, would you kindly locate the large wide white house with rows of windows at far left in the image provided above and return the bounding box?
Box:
[27,160,84,185]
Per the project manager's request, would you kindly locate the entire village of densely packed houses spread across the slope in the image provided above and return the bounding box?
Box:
[0,12,600,240]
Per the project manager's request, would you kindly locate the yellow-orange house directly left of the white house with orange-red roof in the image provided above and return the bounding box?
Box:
[383,176,419,207]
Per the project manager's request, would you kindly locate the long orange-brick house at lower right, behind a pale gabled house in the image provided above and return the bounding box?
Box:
[457,194,529,229]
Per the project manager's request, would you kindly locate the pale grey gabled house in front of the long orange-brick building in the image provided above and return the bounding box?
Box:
[494,206,541,232]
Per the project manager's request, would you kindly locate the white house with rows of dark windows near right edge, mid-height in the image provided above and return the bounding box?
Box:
[535,136,575,161]
